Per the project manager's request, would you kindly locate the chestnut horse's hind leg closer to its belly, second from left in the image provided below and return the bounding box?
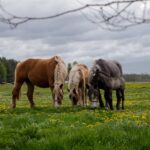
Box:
[27,82,35,108]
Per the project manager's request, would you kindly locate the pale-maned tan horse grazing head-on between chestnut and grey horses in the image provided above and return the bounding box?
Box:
[68,64,89,105]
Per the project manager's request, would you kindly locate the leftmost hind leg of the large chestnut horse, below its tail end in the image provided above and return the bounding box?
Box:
[12,82,23,108]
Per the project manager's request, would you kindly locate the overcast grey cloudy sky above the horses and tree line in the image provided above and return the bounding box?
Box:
[0,0,150,73]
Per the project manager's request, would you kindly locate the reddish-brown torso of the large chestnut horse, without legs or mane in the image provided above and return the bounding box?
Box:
[16,57,57,87]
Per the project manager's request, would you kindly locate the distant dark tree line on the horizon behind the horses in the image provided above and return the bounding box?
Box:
[0,57,150,84]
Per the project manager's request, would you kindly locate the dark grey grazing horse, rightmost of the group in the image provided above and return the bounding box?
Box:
[88,59,125,110]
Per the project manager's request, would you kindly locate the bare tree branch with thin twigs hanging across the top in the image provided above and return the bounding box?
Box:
[0,0,150,31]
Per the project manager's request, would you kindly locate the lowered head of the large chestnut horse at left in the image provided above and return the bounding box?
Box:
[53,84,64,107]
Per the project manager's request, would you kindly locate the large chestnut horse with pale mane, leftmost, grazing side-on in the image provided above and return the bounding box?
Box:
[12,56,67,108]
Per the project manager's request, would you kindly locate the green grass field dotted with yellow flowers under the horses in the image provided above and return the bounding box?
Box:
[0,83,150,150]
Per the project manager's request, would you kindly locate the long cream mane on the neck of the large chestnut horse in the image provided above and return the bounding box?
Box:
[54,56,68,86]
